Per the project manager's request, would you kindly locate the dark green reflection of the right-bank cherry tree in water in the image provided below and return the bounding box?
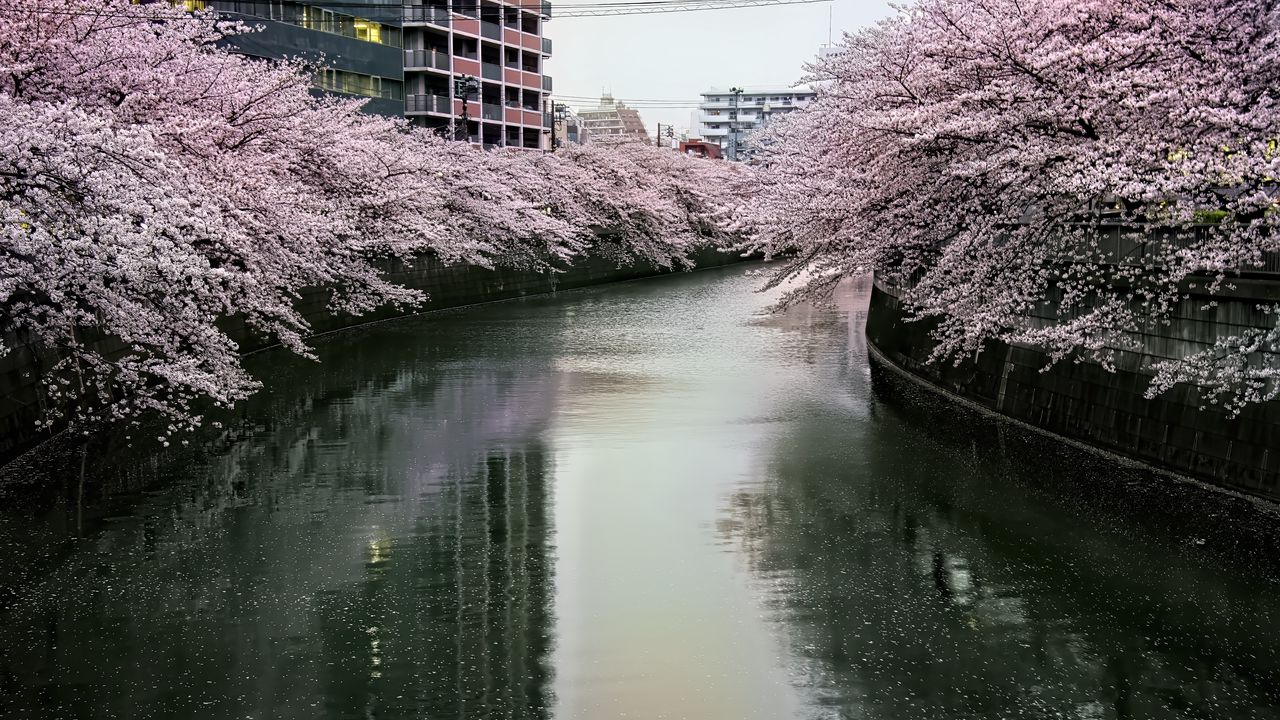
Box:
[721,371,1280,719]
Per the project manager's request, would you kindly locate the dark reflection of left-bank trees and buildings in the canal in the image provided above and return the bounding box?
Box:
[0,316,558,717]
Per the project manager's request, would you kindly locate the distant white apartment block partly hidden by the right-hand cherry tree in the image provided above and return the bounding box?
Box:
[698,87,814,160]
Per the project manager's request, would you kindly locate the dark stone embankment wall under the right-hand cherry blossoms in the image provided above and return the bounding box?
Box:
[867,282,1280,501]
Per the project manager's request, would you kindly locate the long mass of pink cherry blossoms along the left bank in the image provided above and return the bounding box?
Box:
[0,0,747,437]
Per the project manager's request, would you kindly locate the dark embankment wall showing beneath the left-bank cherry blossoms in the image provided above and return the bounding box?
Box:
[0,249,740,464]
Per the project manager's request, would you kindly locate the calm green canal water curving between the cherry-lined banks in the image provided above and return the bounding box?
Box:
[0,266,1280,720]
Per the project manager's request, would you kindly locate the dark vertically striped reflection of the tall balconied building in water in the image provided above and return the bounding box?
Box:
[314,448,552,719]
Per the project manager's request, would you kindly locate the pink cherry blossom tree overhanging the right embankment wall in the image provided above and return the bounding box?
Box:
[750,0,1280,410]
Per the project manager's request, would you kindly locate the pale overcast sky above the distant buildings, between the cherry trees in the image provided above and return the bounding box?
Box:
[545,0,891,133]
